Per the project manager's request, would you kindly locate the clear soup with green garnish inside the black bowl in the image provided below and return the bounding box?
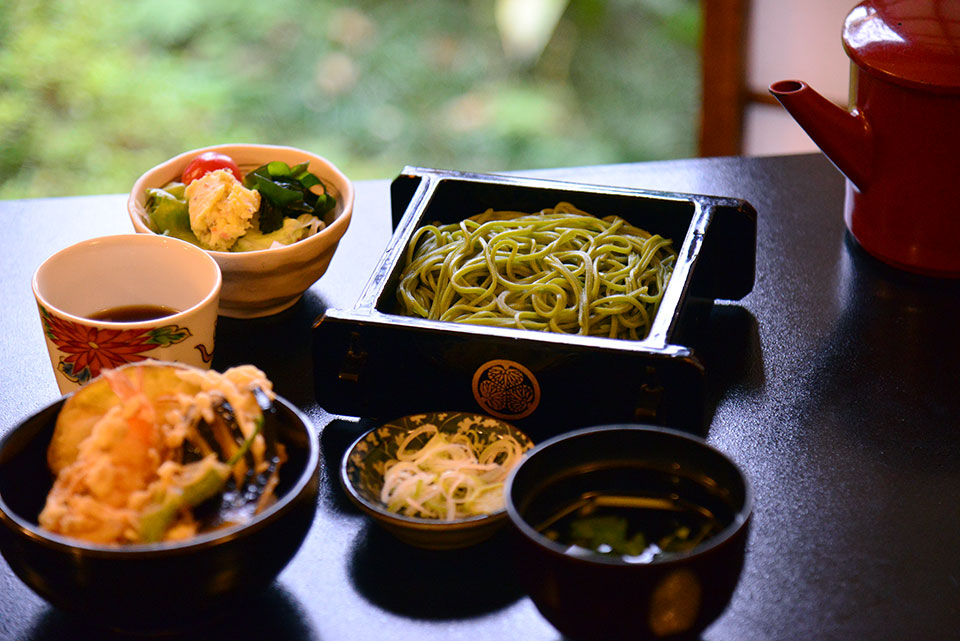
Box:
[524,466,735,563]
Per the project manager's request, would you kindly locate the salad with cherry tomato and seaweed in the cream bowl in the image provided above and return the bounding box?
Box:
[146,152,336,252]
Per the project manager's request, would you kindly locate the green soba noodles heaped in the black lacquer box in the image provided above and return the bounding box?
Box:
[397,202,677,340]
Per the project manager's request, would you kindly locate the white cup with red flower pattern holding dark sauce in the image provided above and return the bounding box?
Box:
[33,234,222,394]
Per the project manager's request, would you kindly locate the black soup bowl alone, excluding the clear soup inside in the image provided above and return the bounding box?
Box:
[506,425,753,641]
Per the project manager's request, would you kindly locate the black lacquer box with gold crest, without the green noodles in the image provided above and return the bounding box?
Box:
[313,167,756,440]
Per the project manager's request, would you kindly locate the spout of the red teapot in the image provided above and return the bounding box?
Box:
[770,80,872,191]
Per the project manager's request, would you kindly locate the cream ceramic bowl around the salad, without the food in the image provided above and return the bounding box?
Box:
[127,144,354,318]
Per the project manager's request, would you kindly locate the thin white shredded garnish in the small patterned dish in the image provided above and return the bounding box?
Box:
[380,423,523,521]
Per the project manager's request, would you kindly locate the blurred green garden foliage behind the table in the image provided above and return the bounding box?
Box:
[0,0,699,198]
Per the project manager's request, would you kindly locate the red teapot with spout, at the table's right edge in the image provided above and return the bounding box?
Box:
[770,0,960,278]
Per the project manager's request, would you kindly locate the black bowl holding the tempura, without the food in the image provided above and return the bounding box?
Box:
[0,397,320,632]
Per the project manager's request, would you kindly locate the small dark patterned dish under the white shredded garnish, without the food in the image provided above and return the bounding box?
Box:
[340,412,533,550]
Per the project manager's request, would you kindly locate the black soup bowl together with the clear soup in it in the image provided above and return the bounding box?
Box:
[506,425,753,640]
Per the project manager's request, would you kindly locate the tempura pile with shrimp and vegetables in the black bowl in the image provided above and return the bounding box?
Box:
[39,361,286,544]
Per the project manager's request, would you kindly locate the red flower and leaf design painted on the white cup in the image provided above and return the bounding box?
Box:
[40,306,191,385]
